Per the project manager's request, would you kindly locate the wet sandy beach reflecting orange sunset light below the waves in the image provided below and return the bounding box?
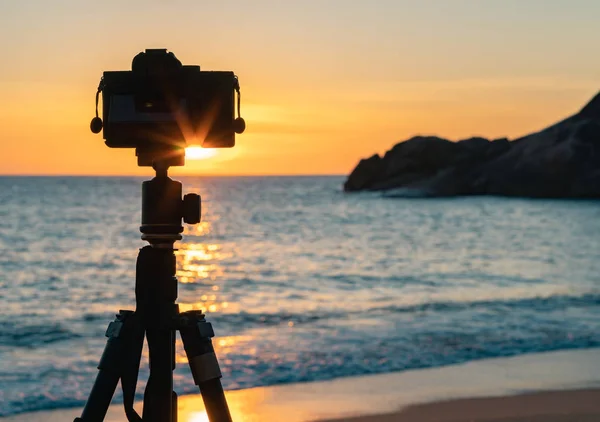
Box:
[0,348,600,422]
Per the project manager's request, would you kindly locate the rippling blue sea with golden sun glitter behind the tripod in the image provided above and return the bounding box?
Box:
[0,177,600,416]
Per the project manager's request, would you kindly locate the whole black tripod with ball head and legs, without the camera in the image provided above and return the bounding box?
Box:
[75,165,231,422]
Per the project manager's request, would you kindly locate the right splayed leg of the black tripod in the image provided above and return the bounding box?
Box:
[179,311,232,422]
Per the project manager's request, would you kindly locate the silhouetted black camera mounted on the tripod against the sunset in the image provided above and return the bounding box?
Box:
[90,49,245,166]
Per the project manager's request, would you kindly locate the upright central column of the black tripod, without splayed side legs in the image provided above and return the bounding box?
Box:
[136,167,183,422]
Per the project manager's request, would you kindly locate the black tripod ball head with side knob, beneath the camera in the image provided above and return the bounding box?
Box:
[140,161,201,248]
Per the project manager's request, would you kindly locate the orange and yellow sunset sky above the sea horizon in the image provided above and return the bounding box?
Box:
[0,0,600,175]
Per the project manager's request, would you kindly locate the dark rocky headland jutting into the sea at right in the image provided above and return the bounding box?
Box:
[344,93,600,198]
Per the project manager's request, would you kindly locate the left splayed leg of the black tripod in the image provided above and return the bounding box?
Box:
[75,311,135,422]
